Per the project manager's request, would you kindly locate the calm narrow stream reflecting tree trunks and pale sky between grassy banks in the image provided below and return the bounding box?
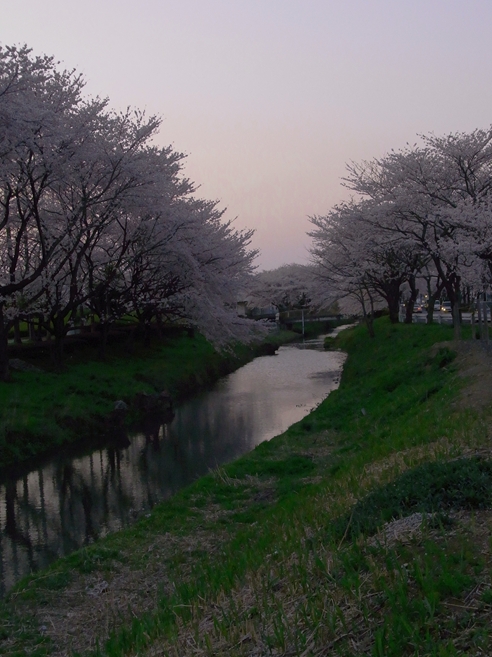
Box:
[0,340,344,594]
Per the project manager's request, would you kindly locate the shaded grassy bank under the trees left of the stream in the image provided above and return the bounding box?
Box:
[0,331,296,468]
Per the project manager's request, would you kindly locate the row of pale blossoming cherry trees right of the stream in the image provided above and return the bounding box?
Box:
[309,128,492,336]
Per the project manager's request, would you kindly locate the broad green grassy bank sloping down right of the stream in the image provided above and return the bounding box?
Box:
[4,319,492,657]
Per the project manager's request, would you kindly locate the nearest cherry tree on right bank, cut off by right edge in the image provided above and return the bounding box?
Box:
[338,130,492,337]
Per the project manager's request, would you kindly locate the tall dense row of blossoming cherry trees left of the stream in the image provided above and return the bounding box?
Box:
[0,47,257,380]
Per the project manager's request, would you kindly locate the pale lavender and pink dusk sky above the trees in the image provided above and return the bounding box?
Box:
[0,0,492,270]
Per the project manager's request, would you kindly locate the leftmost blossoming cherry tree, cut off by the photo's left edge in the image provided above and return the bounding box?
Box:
[0,42,91,380]
